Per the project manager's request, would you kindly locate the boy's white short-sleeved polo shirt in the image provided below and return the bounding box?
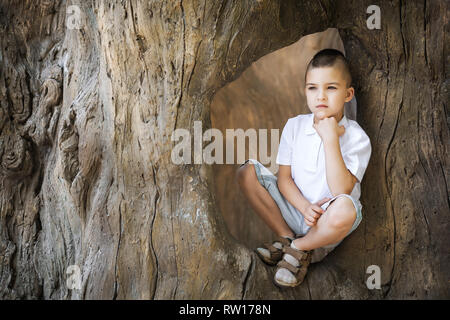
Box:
[276,113,372,208]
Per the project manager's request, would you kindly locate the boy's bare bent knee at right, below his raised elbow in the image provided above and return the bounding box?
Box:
[327,197,356,229]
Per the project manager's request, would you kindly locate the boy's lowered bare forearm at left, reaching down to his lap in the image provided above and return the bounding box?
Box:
[277,165,311,213]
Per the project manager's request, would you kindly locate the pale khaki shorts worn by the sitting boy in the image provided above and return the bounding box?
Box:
[241,159,362,263]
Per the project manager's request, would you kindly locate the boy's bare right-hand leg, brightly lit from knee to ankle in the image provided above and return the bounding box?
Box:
[294,197,356,250]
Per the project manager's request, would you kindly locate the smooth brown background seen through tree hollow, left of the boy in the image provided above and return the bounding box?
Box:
[211,28,345,249]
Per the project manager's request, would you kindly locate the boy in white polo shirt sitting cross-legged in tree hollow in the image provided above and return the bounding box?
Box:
[237,49,372,287]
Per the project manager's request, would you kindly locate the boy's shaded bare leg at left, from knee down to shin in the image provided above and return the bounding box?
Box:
[236,162,294,237]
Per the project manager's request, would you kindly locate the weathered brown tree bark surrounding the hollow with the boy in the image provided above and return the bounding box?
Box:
[0,0,450,299]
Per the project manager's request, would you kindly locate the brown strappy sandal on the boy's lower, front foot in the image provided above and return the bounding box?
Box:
[273,246,313,287]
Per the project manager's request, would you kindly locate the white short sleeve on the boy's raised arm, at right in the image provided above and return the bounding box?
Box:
[342,129,372,182]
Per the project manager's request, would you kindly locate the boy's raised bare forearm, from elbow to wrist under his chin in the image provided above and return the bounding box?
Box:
[323,136,357,197]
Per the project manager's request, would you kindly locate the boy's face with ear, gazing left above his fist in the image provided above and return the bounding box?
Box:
[305,66,354,123]
